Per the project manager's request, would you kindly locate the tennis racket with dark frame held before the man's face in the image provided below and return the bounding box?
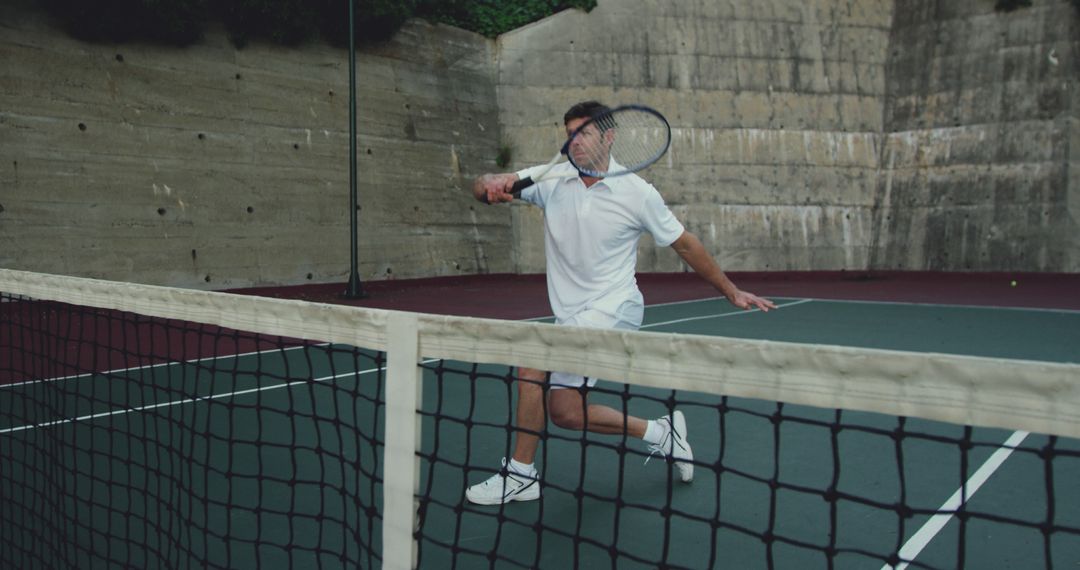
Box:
[494,105,672,198]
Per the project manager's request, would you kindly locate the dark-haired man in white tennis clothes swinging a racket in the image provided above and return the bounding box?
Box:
[465,101,775,504]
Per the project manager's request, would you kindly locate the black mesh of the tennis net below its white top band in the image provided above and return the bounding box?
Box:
[0,273,1080,569]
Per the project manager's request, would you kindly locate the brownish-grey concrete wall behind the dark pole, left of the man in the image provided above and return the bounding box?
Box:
[0,3,511,288]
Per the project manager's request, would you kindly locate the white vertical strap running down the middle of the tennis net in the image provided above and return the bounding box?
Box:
[382,312,422,570]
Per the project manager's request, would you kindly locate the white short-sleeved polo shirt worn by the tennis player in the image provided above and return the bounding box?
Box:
[517,162,684,321]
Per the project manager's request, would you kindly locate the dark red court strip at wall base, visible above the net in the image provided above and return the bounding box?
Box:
[232,271,1080,318]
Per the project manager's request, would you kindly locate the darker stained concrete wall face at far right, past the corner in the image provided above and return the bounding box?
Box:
[870,0,1080,272]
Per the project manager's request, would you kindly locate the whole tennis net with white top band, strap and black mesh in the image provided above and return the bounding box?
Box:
[0,270,1080,568]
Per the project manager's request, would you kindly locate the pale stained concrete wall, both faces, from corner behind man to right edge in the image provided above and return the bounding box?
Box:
[499,0,1080,272]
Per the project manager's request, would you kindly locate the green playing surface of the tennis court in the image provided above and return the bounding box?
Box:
[0,299,1080,569]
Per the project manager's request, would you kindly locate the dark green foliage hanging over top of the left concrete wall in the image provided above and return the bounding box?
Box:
[38,0,596,46]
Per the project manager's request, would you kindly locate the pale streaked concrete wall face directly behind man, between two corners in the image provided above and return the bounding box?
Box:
[499,0,893,272]
